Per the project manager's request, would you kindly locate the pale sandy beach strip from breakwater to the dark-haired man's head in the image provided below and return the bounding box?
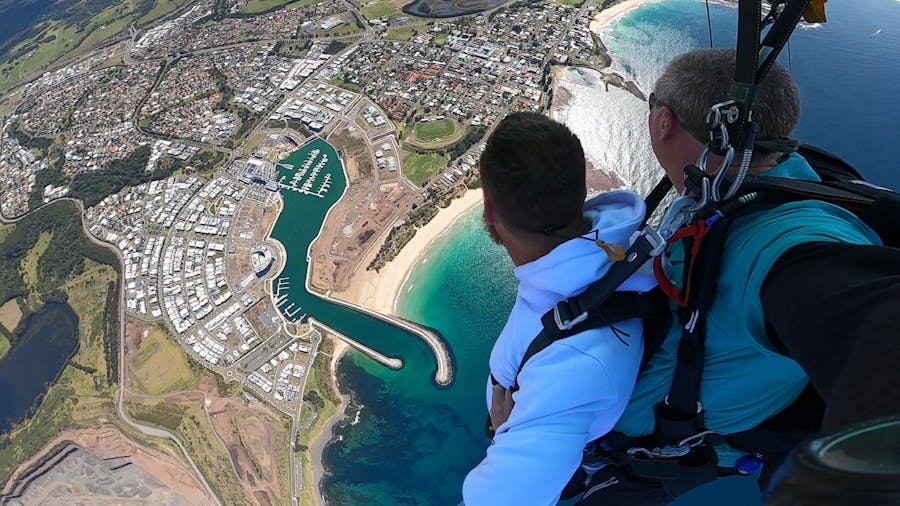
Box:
[332,189,482,315]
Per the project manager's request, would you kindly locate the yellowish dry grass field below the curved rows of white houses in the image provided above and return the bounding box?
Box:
[128,329,197,395]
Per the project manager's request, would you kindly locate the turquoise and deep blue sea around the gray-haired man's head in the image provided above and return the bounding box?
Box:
[604,0,900,190]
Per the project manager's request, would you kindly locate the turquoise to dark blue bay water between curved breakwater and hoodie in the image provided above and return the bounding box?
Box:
[324,211,515,505]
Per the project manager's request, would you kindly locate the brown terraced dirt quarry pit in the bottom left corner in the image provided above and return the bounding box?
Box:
[0,426,214,506]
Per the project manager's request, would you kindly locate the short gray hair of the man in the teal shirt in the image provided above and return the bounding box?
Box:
[654,49,800,143]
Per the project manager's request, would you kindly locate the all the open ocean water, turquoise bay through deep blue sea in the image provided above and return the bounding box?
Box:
[324,0,900,506]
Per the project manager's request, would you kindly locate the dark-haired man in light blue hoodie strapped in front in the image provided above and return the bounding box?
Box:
[463,113,655,506]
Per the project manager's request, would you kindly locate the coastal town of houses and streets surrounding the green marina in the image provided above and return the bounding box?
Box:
[0,0,628,504]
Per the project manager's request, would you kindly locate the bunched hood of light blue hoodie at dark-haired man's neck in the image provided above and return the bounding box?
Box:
[515,190,654,313]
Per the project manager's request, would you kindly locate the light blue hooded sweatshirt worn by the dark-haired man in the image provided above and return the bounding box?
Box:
[463,191,656,506]
